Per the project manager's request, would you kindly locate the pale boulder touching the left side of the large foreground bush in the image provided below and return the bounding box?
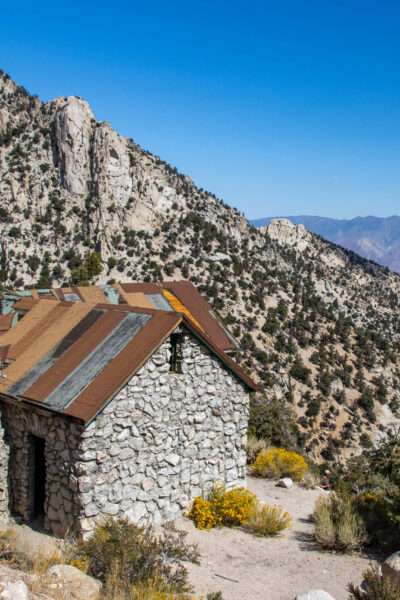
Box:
[47,565,101,600]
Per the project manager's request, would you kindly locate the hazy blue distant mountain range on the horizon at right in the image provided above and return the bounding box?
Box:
[252,215,400,273]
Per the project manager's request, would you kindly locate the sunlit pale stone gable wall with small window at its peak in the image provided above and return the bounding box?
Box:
[78,335,248,533]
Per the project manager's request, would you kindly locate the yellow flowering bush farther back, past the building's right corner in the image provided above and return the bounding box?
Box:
[252,448,308,481]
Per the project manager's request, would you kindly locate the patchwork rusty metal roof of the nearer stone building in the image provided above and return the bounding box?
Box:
[0,292,256,422]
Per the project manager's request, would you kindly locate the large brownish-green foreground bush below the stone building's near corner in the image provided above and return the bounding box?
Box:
[75,519,199,598]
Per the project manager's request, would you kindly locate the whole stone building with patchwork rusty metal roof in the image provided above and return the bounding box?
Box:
[0,284,255,536]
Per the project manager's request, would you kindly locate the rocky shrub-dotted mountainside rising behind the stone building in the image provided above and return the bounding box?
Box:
[0,73,400,460]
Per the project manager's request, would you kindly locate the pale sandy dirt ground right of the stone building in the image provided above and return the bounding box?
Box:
[177,478,371,600]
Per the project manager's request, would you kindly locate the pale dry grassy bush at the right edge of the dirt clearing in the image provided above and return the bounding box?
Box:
[313,494,367,552]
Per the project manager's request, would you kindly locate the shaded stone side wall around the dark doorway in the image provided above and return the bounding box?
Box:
[0,404,83,536]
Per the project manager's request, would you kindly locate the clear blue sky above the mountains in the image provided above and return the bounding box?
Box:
[0,0,400,218]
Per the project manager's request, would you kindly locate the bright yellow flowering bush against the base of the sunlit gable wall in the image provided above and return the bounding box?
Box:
[188,485,257,529]
